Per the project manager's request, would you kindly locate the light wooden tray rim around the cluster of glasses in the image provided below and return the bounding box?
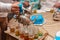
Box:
[4,27,48,40]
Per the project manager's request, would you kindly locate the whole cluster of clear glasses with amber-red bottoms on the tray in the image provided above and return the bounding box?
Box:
[7,24,39,40]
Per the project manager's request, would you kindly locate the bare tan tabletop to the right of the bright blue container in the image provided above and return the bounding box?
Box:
[4,12,60,40]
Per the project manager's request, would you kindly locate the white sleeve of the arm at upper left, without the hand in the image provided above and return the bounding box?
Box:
[0,2,12,12]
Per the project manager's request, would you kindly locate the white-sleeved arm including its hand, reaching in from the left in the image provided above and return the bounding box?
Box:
[0,2,20,14]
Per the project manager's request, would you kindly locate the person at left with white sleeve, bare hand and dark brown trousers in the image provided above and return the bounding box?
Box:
[0,2,19,40]
